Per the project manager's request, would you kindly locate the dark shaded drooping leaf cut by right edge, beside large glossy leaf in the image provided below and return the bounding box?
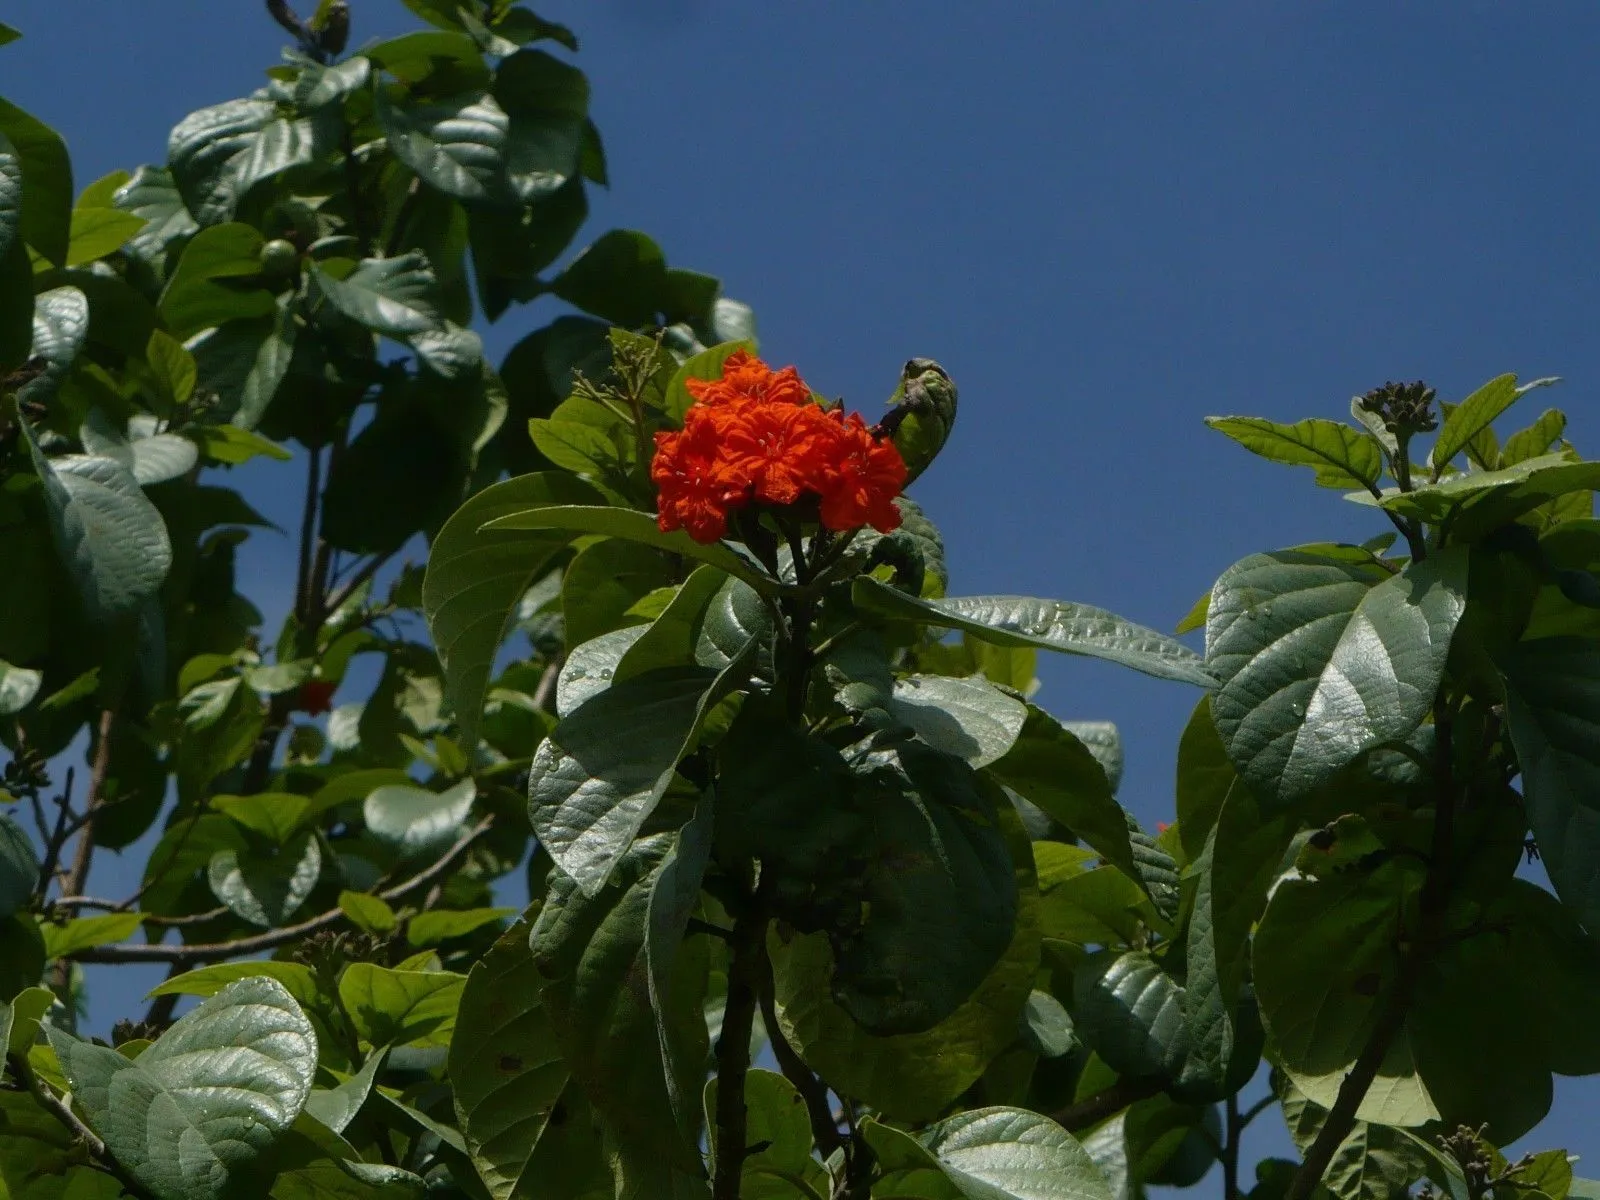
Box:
[1502,637,1600,930]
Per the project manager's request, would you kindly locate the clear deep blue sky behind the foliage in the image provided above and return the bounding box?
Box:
[0,0,1600,1176]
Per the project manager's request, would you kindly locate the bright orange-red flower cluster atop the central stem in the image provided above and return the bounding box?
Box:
[650,350,906,542]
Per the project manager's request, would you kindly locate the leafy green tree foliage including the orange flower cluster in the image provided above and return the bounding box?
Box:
[0,0,1600,1200]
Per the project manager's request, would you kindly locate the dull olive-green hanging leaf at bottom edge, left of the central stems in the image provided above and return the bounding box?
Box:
[448,922,573,1200]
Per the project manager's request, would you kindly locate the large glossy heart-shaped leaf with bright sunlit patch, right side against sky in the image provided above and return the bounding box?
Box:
[1206,547,1467,803]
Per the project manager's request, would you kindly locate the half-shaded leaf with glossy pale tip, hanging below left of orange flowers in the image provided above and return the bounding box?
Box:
[528,659,754,896]
